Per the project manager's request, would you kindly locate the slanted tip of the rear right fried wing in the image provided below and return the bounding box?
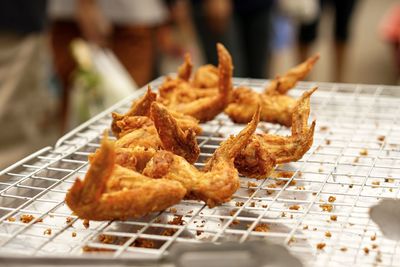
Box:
[265,54,319,95]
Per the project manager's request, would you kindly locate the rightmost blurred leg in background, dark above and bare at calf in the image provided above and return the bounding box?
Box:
[334,0,357,82]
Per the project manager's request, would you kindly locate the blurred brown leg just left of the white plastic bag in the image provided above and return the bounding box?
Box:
[50,21,81,132]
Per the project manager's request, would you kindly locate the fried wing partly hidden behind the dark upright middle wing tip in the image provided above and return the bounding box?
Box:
[111,86,202,138]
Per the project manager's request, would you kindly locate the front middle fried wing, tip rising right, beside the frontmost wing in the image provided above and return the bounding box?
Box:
[143,110,259,207]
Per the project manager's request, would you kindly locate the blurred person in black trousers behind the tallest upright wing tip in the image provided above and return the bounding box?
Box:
[191,0,274,78]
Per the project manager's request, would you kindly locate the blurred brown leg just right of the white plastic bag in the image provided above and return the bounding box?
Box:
[111,26,156,87]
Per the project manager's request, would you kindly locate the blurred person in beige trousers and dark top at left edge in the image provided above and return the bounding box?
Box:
[0,0,56,168]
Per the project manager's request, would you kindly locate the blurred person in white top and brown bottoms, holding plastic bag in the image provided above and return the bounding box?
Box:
[49,0,177,133]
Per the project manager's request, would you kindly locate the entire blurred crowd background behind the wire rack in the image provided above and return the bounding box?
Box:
[0,0,400,169]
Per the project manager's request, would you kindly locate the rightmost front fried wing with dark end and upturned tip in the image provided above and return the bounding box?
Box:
[235,88,317,178]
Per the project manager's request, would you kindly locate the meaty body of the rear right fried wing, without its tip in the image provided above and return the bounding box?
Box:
[225,87,296,127]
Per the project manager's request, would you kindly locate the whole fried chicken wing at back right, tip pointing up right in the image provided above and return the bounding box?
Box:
[225,55,319,127]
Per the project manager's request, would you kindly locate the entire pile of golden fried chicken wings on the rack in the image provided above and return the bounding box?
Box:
[66,44,319,220]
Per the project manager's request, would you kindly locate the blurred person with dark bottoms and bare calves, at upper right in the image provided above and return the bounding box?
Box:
[298,0,357,82]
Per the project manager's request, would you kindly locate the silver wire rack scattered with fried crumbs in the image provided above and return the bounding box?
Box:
[0,78,400,266]
